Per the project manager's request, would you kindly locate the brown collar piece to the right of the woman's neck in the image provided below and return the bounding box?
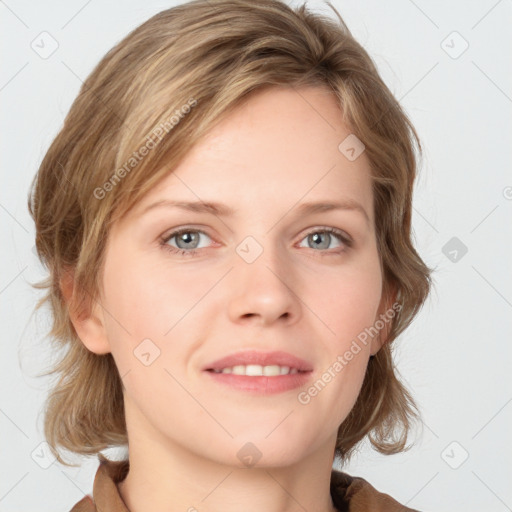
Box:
[331,470,418,512]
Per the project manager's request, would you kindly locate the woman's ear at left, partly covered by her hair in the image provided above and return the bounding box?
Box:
[60,270,110,354]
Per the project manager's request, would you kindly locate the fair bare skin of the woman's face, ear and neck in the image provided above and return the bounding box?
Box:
[66,87,389,512]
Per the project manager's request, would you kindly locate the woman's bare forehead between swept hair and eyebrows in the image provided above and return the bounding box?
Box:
[124,86,372,225]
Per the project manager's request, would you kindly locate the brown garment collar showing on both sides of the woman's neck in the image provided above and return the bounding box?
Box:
[70,453,418,512]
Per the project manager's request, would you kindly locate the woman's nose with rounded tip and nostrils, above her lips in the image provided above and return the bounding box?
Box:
[228,247,302,326]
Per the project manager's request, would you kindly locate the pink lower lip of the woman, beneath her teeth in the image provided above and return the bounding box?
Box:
[206,371,312,395]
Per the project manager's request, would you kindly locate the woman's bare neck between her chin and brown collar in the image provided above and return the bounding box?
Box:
[118,400,336,512]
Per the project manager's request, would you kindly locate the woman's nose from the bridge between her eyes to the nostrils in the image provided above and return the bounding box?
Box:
[229,235,300,323]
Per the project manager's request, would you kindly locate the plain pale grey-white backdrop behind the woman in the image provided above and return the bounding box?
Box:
[0,0,512,512]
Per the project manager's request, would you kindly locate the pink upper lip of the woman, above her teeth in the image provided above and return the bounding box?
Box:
[203,350,313,371]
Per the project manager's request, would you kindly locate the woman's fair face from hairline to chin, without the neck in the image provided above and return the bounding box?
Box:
[88,87,382,466]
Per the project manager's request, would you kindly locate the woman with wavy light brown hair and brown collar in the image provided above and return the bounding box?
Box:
[29,0,430,512]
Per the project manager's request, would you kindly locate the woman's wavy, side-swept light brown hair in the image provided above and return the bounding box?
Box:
[29,0,431,464]
